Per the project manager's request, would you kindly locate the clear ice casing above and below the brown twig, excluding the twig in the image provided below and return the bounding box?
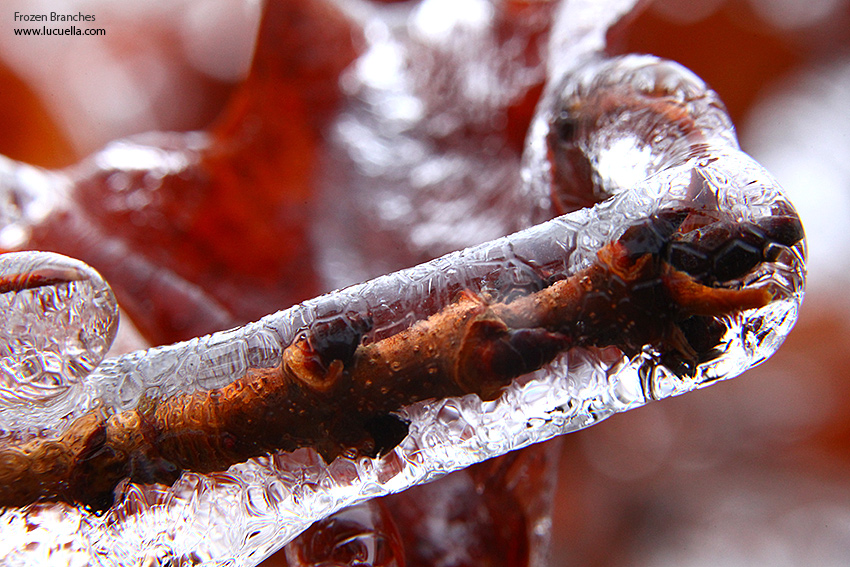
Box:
[0,3,804,565]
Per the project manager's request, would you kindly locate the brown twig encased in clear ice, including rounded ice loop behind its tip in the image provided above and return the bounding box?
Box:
[0,1,805,565]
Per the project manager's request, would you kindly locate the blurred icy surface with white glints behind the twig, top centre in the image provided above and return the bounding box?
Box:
[314,0,560,288]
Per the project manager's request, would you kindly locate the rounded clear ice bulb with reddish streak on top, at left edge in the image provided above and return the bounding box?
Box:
[0,251,118,405]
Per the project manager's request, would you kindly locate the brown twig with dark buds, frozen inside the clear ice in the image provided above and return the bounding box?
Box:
[0,210,802,510]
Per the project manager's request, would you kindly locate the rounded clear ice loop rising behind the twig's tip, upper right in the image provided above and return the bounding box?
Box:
[523,55,739,222]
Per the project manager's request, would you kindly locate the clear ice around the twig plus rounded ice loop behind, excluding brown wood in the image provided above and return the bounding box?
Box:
[0,3,805,565]
